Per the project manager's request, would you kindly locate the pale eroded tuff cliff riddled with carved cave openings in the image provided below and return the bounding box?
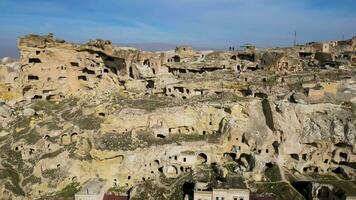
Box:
[0,35,356,199]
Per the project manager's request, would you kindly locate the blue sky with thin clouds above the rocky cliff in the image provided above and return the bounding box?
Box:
[0,0,356,57]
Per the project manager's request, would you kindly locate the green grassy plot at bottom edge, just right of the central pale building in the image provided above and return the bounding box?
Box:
[256,182,305,200]
